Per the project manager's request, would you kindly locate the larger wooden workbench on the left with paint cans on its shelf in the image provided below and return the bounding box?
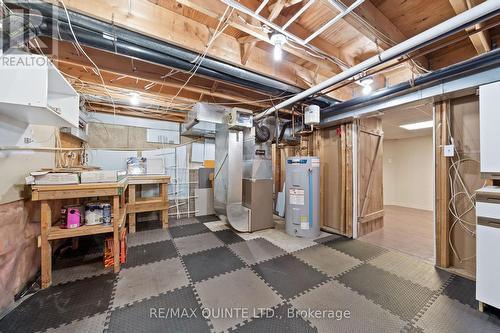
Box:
[31,178,128,288]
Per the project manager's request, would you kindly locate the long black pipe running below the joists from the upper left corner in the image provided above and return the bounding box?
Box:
[17,2,338,107]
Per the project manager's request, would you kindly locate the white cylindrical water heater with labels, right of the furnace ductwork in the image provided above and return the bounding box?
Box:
[285,156,320,238]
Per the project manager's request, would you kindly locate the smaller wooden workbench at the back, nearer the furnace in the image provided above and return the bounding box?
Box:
[127,175,170,233]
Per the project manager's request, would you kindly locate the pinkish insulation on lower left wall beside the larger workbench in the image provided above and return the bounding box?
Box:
[0,200,40,312]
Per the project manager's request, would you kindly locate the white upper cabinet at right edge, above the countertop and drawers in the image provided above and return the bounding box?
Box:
[479,82,500,178]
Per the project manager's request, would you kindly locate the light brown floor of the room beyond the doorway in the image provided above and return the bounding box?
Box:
[360,206,434,263]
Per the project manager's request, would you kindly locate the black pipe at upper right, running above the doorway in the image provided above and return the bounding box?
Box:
[321,49,500,123]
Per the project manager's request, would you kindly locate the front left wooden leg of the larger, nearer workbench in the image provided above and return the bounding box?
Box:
[40,200,52,289]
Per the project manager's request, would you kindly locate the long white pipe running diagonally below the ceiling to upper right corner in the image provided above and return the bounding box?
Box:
[254,0,500,120]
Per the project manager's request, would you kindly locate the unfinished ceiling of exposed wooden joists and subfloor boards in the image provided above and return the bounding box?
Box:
[13,0,499,121]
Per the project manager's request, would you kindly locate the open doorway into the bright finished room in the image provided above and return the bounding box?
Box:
[358,103,435,263]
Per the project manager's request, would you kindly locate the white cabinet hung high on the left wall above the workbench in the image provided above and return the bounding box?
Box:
[0,53,80,127]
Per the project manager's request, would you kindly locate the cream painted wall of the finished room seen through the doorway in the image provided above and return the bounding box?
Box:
[384,136,434,210]
